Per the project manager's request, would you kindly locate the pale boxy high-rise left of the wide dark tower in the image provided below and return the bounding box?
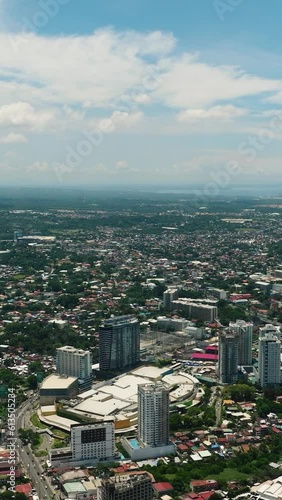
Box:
[56,346,92,391]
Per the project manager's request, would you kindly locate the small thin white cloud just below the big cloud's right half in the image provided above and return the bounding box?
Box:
[178,104,248,122]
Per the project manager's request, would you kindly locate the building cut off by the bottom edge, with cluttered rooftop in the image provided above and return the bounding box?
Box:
[97,471,153,500]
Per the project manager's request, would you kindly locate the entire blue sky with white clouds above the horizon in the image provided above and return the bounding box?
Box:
[0,0,282,188]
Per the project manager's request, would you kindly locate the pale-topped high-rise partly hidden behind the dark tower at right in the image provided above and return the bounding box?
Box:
[229,320,254,366]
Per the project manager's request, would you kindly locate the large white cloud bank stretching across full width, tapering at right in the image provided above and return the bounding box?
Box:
[0,29,282,116]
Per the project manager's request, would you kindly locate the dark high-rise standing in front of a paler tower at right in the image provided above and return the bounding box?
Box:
[218,331,239,384]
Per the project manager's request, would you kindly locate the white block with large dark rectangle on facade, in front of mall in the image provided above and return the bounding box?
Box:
[71,422,115,462]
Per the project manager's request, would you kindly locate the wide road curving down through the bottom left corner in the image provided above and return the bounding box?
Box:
[16,398,57,500]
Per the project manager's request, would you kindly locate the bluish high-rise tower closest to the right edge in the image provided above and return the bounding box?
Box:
[258,333,281,387]
